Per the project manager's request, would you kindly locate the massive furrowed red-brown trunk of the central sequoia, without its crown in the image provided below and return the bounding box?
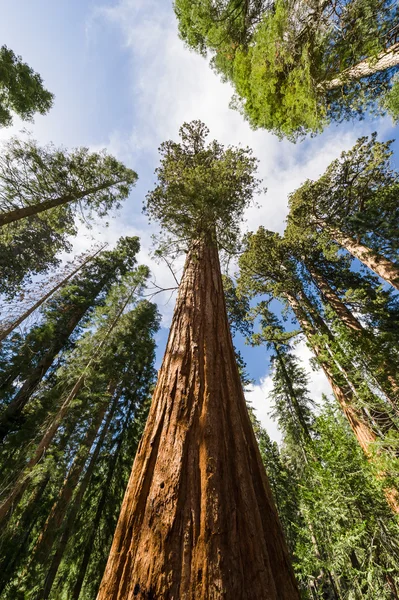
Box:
[98,243,299,600]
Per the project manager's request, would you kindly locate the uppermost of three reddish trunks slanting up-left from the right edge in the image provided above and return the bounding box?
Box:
[319,222,399,290]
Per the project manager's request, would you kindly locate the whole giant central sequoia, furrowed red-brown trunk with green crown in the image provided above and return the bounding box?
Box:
[98,122,299,600]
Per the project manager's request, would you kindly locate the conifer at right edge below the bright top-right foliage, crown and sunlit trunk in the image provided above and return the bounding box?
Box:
[287,134,399,289]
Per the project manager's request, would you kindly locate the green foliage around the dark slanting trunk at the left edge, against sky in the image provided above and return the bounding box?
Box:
[0,138,137,294]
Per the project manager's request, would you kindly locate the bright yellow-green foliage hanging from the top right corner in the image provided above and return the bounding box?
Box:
[175,0,398,140]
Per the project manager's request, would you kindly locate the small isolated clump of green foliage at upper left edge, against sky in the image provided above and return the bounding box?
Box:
[0,46,54,127]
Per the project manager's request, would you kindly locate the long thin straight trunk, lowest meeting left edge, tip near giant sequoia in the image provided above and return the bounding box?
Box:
[0,287,136,523]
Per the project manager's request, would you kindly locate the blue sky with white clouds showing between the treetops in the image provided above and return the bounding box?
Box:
[0,0,397,439]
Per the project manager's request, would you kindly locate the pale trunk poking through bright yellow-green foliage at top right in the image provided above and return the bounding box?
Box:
[324,42,399,90]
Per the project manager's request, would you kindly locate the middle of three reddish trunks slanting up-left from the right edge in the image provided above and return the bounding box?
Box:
[306,265,399,411]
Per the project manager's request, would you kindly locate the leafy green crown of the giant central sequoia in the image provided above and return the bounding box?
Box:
[144,121,260,252]
